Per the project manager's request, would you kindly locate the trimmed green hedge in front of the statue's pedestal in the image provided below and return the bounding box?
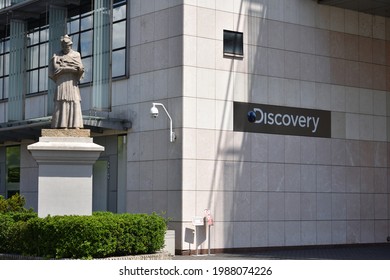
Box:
[0,212,166,259]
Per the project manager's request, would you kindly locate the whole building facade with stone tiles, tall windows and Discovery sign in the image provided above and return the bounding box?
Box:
[0,0,390,252]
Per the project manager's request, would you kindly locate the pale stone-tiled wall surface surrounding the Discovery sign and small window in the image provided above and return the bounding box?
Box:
[127,0,390,250]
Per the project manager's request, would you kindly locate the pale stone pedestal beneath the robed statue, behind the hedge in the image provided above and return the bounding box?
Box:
[27,129,104,217]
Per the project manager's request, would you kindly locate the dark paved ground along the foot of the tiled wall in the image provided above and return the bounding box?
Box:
[173,244,390,260]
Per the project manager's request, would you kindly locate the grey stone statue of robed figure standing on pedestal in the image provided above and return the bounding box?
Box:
[49,35,84,129]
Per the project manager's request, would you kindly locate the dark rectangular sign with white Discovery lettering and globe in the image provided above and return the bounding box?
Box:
[233,102,331,138]
